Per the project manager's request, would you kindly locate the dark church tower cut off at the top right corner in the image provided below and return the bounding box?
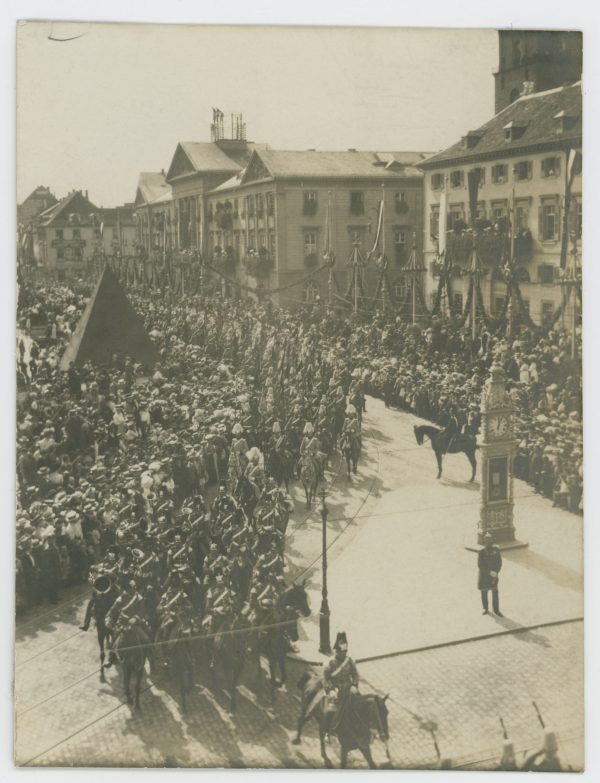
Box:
[494,30,583,114]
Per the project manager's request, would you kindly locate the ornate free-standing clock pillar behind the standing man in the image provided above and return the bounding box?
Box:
[468,363,527,549]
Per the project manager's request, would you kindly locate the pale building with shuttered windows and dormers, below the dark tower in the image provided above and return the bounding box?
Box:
[421,83,582,330]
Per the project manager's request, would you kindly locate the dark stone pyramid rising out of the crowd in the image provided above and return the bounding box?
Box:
[60,267,158,370]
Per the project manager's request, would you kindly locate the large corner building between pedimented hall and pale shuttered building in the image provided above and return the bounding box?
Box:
[205,149,426,305]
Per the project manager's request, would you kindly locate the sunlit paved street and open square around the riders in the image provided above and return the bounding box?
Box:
[15,398,583,769]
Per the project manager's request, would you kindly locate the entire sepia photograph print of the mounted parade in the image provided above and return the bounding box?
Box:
[15,20,587,774]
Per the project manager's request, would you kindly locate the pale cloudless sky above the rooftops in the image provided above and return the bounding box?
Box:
[17,22,498,207]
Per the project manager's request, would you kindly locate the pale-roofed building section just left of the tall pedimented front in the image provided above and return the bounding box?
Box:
[134,170,175,257]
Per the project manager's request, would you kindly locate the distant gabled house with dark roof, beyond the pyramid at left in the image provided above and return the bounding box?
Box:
[33,190,136,280]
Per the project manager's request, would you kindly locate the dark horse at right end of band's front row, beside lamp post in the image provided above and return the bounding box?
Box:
[255,580,310,704]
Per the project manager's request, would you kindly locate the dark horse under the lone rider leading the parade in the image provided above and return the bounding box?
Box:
[292,671,391,769]
